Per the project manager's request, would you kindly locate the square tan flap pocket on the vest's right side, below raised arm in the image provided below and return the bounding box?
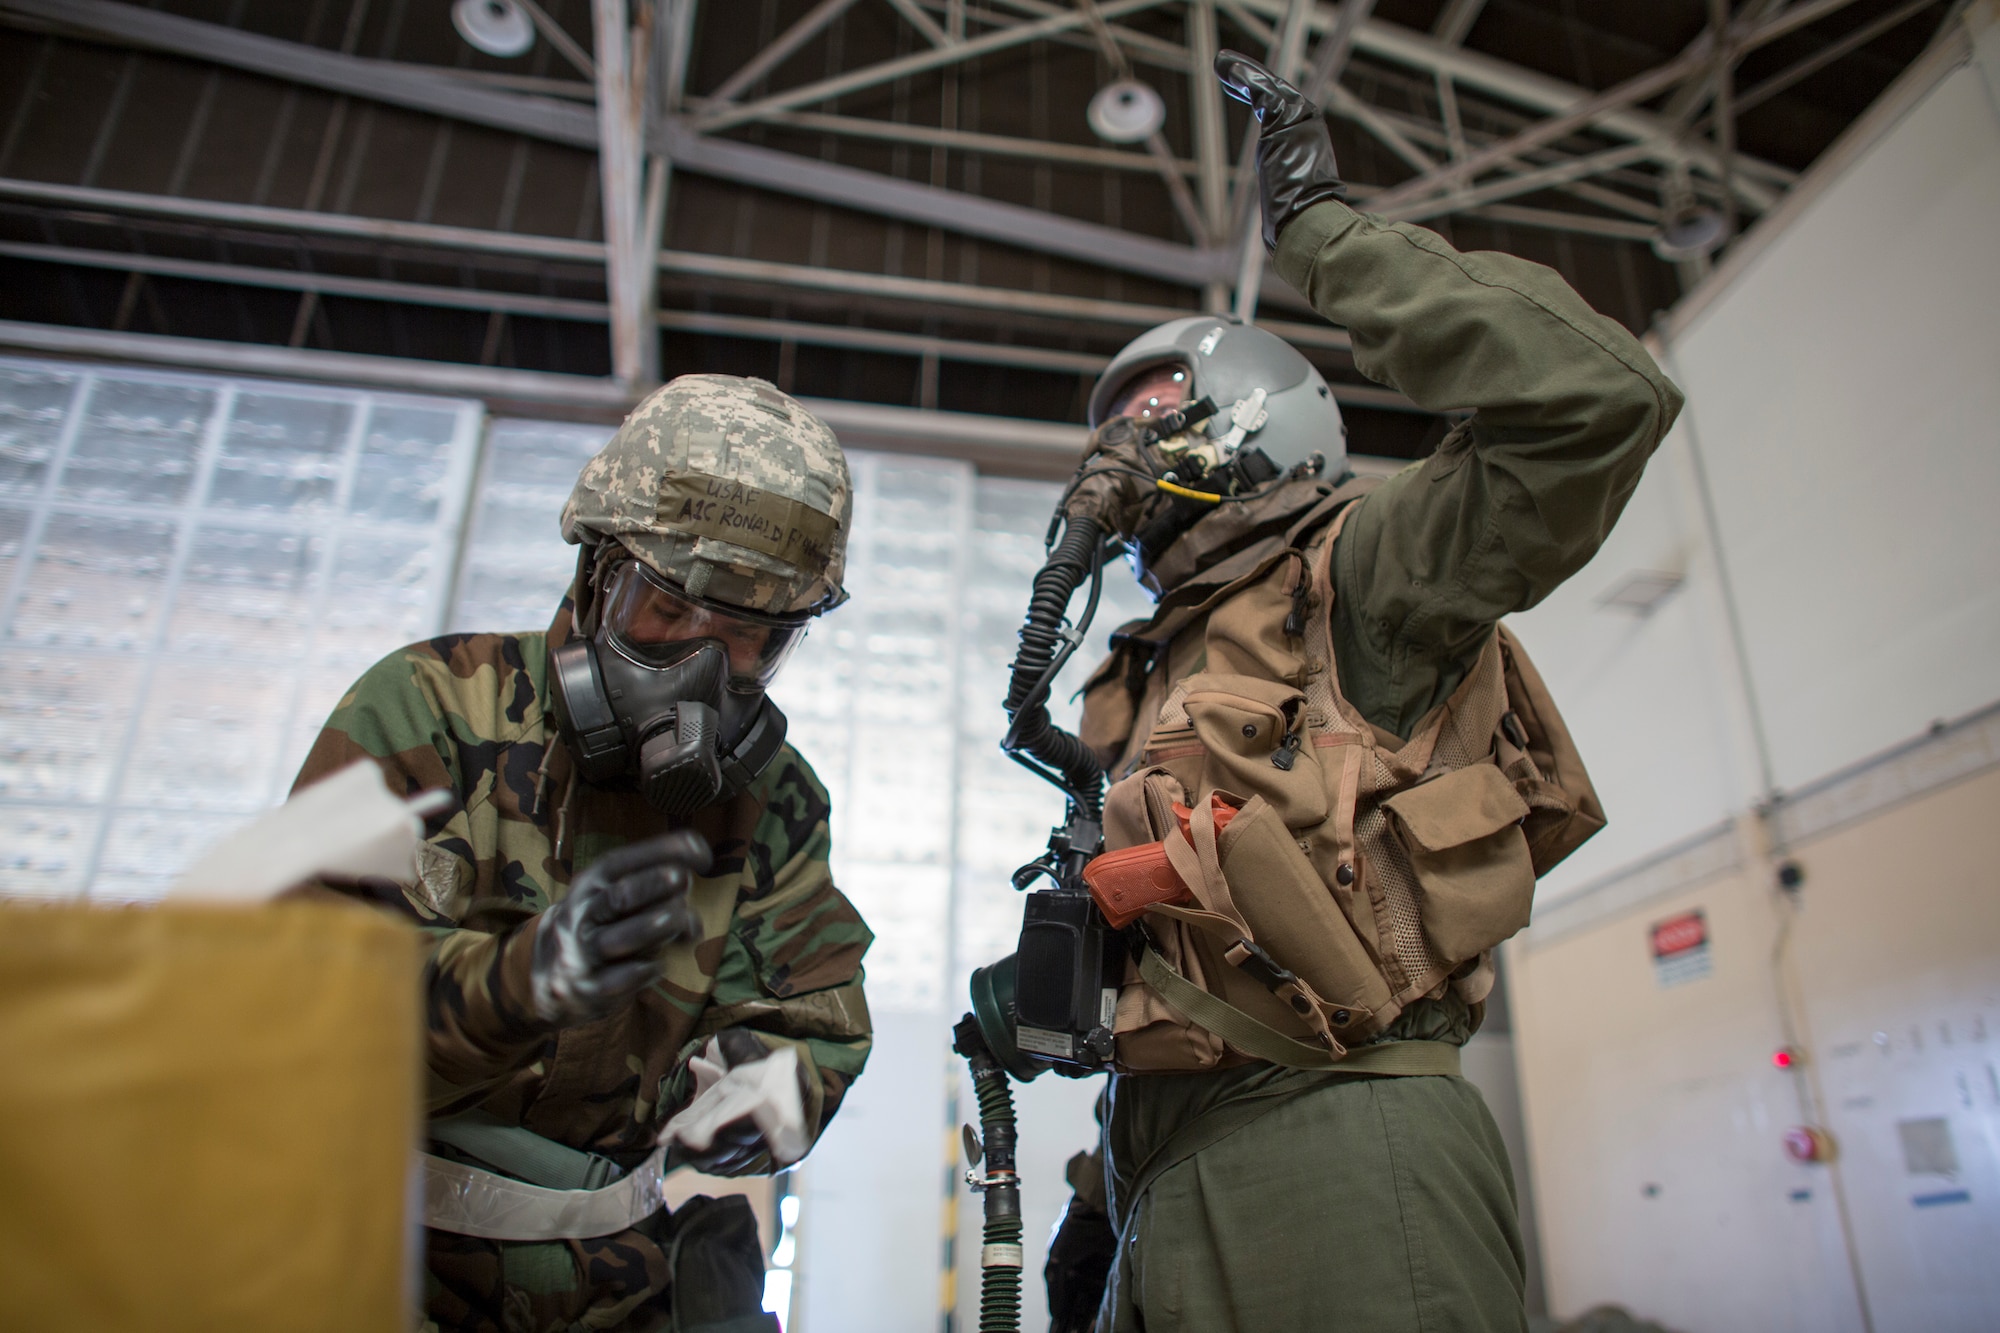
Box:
[1382,763,1534,963]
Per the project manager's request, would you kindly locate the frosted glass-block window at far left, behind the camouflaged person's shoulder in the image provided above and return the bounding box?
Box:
[0,358,480,899]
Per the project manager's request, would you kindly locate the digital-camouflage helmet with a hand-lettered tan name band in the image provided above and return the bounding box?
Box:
[562,374,854,614]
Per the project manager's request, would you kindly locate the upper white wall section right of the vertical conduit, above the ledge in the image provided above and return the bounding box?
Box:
[1670,66,2000,789]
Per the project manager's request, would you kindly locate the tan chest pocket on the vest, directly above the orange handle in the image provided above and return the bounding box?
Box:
[1186,673,1328,829]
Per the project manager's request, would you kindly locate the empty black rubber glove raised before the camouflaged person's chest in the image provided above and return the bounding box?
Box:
[532,831,714,1027]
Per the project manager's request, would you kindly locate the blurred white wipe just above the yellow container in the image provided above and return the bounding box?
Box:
[166,759,432,903]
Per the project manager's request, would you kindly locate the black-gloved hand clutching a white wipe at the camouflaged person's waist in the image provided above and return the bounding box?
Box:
[660,1027,812,1175]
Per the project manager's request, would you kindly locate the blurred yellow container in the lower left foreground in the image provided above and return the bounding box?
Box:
[0,903,422,1333]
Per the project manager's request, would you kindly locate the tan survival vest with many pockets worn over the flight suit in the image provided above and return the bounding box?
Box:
[1082,480,1604,1073]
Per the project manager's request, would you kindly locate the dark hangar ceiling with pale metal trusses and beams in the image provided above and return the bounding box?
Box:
[0,0,1960,474]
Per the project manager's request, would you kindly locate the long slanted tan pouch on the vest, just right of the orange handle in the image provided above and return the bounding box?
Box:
[1216,801,1390,1020]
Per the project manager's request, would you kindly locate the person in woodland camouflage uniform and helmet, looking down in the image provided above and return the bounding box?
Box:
[298,376,872,1333]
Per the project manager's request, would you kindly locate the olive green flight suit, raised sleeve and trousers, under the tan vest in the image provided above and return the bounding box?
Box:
[1098,202,1682,1333]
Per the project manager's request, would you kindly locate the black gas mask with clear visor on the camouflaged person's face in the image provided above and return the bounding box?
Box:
[548,560,804,819]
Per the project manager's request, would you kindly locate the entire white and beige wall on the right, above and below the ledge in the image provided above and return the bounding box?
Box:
[1510,39,2000,1333]
